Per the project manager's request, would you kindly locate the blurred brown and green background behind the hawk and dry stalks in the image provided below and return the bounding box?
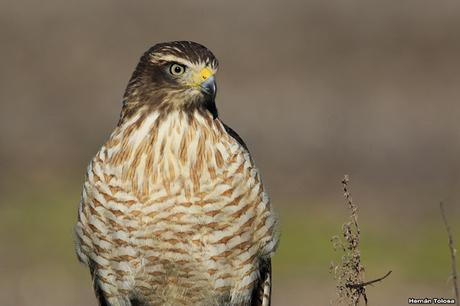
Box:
[0,0,460,306]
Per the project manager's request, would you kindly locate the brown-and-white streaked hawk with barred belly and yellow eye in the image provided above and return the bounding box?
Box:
[76,41,278,306]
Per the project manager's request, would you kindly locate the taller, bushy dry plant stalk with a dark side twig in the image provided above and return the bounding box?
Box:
[331,175,391,306]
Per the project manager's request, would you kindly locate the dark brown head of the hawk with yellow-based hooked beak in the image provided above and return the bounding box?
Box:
[123,41,218,116]
